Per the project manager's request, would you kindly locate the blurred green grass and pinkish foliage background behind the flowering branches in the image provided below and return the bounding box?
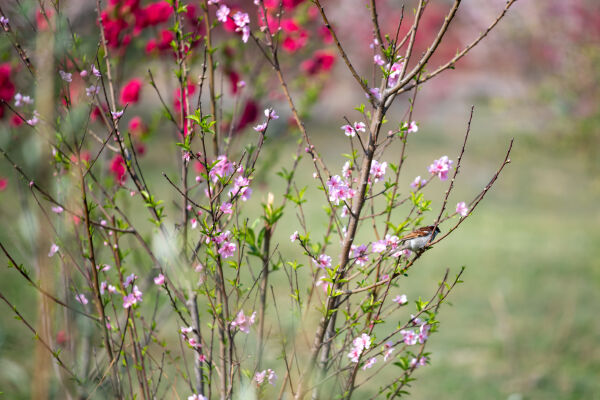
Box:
[0,0,600,400]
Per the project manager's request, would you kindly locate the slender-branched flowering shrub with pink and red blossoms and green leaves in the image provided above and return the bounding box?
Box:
[0,0,514,399]
